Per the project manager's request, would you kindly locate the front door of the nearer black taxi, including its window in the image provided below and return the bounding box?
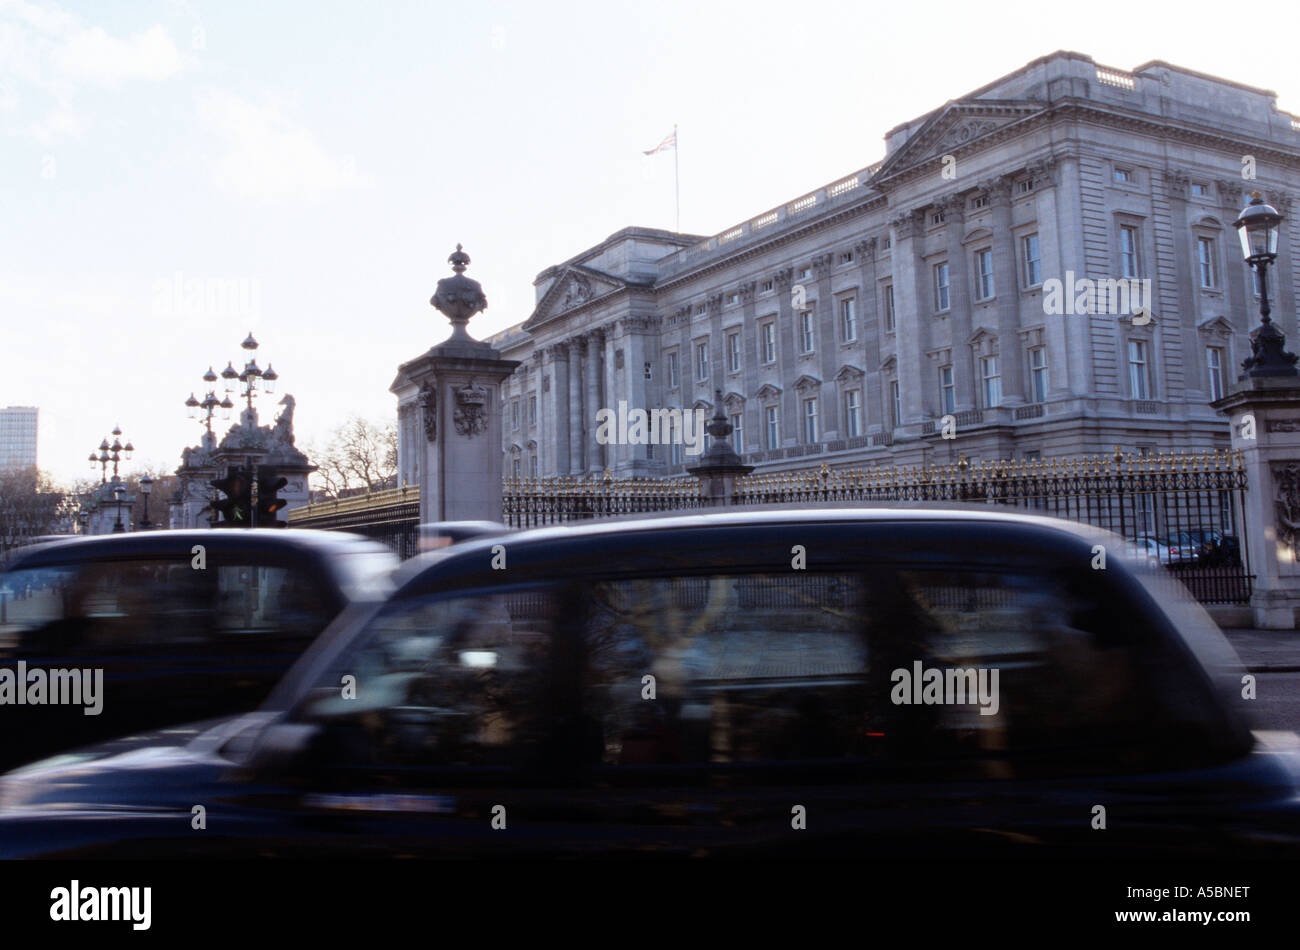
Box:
[250,585,572,858]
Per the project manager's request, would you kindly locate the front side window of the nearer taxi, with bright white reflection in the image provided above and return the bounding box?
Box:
[296,590,554,767]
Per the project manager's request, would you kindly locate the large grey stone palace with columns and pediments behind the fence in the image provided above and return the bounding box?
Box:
[402,52,1300,481]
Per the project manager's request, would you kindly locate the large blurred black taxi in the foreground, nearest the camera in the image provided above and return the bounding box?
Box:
[0,509,1300,867]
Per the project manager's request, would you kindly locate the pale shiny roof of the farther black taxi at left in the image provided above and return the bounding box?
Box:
[7,528,389,571]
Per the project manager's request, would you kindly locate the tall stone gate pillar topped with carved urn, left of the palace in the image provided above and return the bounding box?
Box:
[399,244,519,522]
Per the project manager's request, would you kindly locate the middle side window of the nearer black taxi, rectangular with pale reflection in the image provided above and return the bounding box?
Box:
[581,574,874,765]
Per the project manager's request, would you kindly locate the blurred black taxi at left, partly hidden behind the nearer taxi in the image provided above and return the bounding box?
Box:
[0,529,398,768]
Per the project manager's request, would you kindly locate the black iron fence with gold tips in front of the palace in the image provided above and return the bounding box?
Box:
[289,451,1253,603]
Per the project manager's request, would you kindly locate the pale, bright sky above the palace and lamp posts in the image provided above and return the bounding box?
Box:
[0,0,1300,480]
